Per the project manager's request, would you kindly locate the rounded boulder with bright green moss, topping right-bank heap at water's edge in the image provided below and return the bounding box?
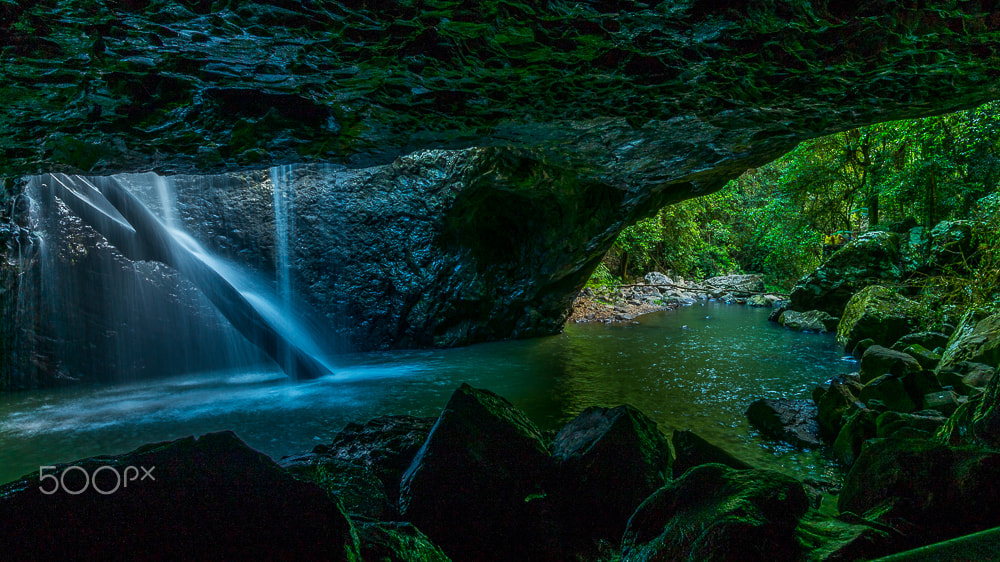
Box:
[837,285,928,349]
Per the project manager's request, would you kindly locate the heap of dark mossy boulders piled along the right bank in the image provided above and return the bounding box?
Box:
[747,286,1000,548]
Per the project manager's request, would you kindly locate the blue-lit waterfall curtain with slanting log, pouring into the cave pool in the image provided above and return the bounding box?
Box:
[21,172,331,380]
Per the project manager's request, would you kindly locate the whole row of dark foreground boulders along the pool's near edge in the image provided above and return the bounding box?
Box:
[0,385,924,561]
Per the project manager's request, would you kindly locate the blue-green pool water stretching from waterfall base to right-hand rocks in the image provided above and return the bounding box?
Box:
[0,302,856,482]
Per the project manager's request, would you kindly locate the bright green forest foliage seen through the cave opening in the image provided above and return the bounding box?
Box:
[599,102,1000,290]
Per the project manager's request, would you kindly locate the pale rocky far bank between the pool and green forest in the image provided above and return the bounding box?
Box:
[569,271,783,322]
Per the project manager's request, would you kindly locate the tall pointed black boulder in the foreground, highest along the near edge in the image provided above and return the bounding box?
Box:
[399,385,561,560]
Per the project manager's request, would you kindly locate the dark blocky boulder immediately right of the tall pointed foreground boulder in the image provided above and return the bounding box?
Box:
[552,406,673,541]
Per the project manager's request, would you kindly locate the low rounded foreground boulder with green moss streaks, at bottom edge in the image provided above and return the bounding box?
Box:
[622,464,809,561]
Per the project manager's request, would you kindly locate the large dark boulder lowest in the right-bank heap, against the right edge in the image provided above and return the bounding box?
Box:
[838,439,1000,546]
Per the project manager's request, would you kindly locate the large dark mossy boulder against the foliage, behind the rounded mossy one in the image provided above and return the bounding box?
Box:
[790,231,904,318]
